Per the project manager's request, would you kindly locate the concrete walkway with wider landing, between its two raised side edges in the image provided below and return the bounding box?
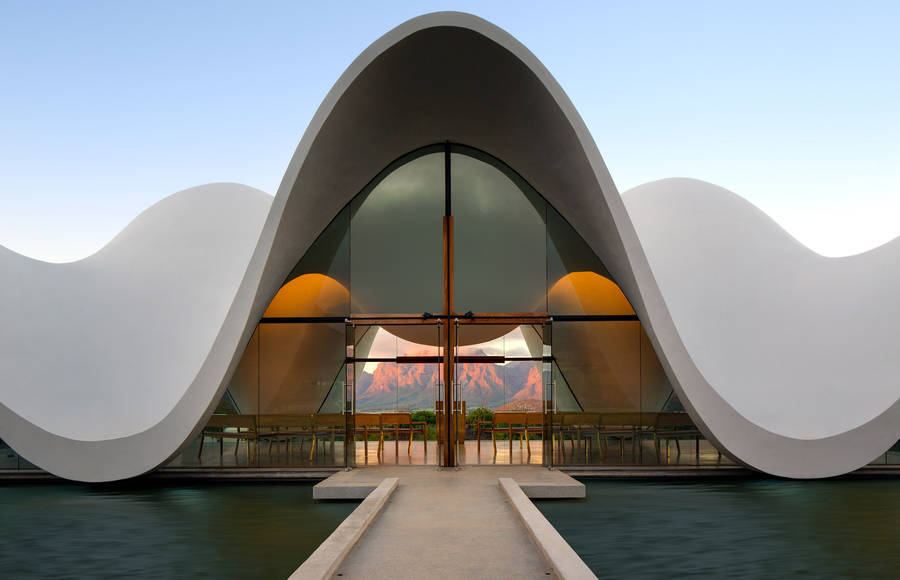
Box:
[320,466,583,580]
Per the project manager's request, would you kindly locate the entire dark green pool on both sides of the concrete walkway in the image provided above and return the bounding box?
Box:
[7,479,900,579]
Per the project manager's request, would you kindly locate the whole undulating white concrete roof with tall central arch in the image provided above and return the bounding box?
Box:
[0,13,900,481]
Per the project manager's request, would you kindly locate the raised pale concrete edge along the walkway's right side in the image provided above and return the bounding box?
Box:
[498,477,597,580]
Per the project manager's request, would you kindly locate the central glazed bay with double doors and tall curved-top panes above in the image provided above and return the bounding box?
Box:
[348,143,552,467]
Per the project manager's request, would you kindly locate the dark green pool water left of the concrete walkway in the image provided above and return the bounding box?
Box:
[0,483,358,579]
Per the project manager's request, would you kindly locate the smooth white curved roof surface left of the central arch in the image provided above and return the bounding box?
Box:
[0,184,272,441]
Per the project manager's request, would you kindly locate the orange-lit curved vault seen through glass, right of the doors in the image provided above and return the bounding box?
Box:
[548,272,634,315]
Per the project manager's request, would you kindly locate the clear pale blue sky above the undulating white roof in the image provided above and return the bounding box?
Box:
[0,0,900,261]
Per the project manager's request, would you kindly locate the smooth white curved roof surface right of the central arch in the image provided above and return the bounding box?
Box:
[623,179,900,439]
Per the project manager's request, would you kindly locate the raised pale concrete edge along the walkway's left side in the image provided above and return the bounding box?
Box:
[289,477,399,580]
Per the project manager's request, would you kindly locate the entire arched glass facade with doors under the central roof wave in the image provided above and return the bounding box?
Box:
[158,144,724,467]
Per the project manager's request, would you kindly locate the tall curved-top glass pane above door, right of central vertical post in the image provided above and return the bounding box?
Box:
[450,147,547,312]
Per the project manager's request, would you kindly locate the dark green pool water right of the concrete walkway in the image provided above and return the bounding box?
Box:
[537,480,900,579]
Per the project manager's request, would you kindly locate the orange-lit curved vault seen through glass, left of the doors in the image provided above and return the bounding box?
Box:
[263,274,350,318]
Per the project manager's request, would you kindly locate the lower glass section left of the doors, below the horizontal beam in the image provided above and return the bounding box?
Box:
[168,319,347,467]
